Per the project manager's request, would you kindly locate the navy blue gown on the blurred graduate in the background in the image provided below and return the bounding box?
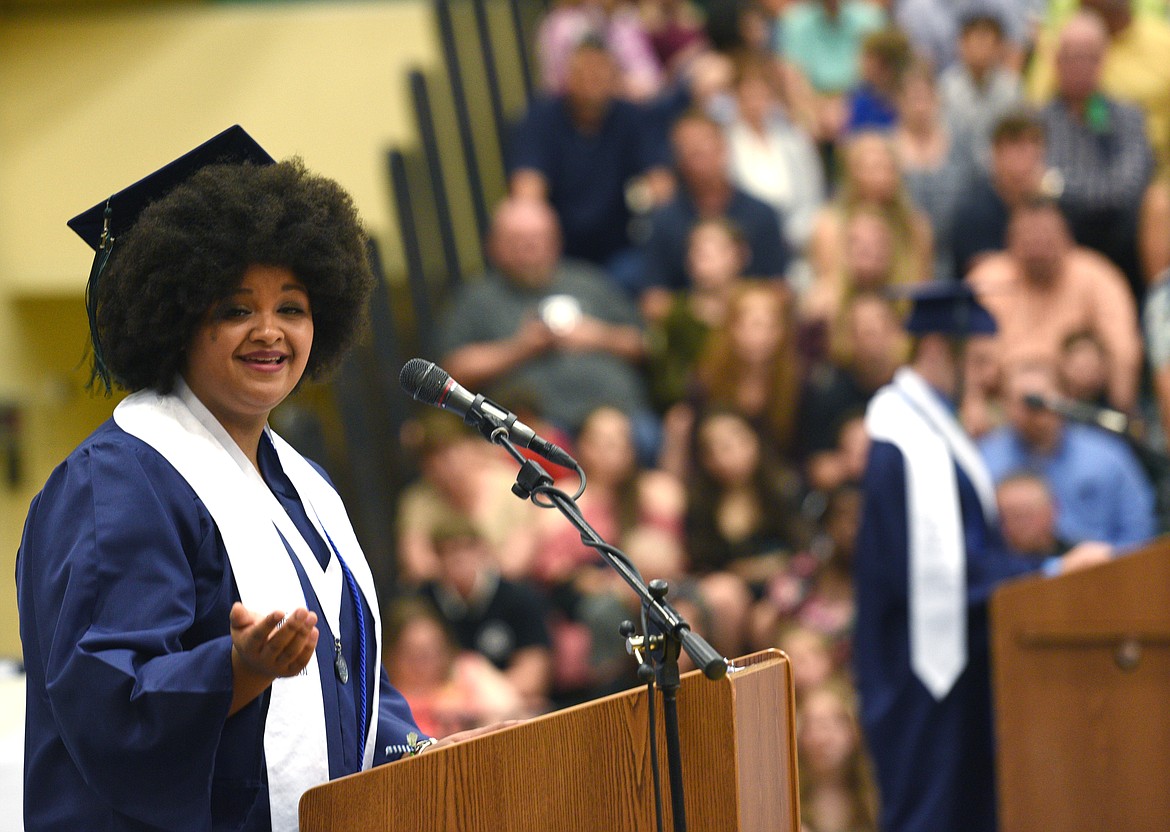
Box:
[854,441,1037,832]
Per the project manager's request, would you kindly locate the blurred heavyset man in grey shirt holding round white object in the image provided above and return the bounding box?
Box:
[439,198,658,453]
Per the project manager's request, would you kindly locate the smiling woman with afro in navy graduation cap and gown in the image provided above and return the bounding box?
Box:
[16,128,435,832]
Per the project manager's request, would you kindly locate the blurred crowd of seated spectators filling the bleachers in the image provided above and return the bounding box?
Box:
[386,0,1170,832]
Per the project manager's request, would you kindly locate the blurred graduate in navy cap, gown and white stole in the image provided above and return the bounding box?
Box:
[854,283,1109,832]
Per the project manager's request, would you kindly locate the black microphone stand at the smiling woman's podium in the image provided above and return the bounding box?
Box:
[472,423,728,832]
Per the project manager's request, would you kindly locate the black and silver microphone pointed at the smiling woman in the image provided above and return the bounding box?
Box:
[398,358,577,468]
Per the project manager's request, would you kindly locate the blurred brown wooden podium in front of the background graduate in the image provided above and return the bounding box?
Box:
[991,537,1170,832]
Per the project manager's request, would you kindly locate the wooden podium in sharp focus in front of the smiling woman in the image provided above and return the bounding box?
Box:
[301,651,800,832]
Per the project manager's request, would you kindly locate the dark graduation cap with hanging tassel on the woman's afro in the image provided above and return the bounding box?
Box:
[68,124,276,393]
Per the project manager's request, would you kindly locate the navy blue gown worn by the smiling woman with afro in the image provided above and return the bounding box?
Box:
[16,420,418,832]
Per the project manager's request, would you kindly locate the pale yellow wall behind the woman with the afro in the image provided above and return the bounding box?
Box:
[0,0,438,656]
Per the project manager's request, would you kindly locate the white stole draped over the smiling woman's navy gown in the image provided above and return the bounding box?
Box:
[113,378,381,832]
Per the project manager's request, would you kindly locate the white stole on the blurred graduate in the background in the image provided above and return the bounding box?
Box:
[866,367,997,700]
